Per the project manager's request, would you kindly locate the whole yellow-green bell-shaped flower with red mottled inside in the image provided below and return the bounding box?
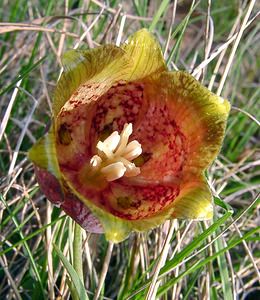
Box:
[29,29,230,242]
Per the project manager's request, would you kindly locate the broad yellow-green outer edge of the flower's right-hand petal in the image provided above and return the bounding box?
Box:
[159,71,230,177]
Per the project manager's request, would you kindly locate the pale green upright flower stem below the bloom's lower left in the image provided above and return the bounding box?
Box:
[73,223,84,284]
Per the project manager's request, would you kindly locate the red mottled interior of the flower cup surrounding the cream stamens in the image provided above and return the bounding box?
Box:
[57,82,186,220]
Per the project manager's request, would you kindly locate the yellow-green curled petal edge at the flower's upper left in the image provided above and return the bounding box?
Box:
[53,45,131,116]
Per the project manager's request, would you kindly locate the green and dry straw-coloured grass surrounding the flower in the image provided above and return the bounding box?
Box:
[0,0,260,300]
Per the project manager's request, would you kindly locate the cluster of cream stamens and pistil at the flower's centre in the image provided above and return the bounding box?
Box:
[90,123,142,181]
